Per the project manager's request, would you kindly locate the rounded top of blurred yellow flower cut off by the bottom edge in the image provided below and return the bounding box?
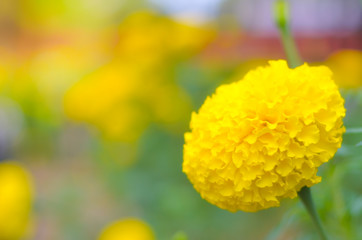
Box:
[98,218,155,240]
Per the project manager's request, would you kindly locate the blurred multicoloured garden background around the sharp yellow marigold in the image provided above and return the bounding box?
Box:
[0,0,362,240]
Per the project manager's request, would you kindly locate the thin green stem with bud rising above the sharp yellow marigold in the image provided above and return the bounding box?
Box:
[274,0,302,68]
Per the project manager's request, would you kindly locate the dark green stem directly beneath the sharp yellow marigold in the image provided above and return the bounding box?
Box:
[298,187,327,240]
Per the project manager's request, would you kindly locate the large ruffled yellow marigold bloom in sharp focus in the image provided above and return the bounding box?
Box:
[183,60,345,212]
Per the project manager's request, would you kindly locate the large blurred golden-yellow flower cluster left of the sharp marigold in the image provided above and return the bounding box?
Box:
[64,12,212,142]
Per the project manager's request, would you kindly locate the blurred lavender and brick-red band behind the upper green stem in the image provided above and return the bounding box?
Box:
[204,0,362,62]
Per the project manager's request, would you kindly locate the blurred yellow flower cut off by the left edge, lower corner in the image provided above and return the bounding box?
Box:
[0,162,33,240]
